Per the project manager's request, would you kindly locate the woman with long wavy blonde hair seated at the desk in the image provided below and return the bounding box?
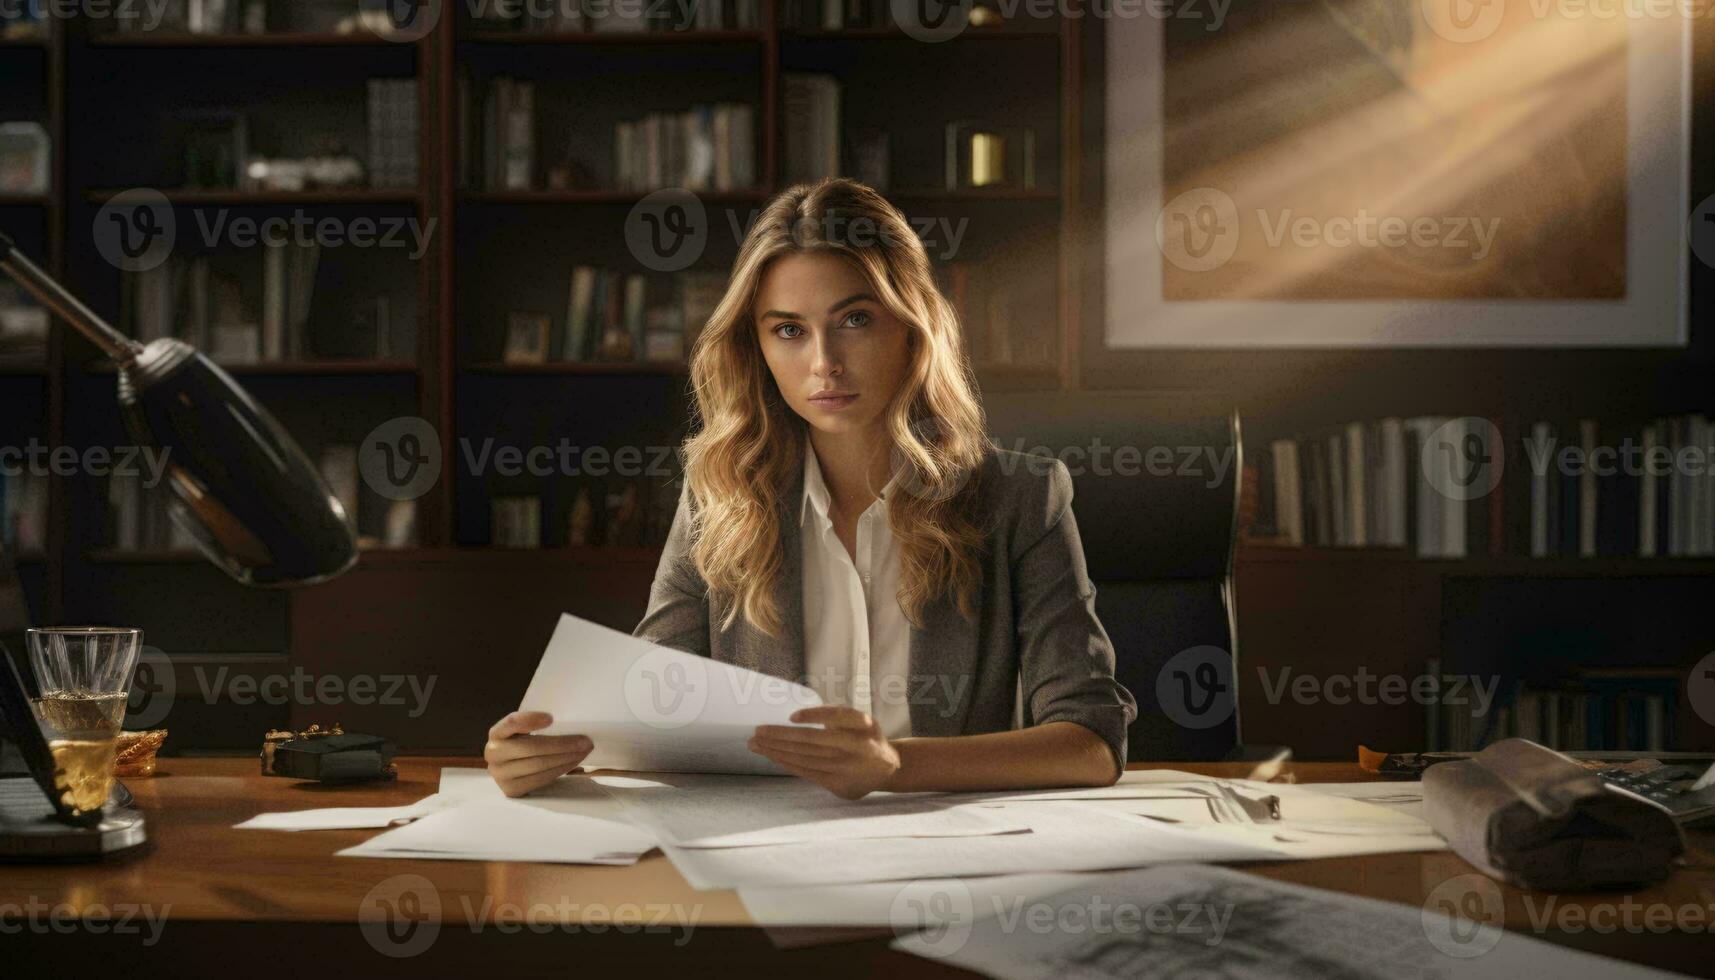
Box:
[485,180,1137,800]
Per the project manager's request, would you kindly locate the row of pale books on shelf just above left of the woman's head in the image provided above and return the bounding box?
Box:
[614,103,756,191]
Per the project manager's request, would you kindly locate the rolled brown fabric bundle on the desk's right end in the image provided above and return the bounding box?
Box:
[1423,738,1686,891]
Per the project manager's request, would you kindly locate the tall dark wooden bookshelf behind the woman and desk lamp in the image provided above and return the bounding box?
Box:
[0,0,1082,696]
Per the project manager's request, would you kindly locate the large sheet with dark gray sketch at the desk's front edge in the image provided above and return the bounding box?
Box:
[894,865,1665,980]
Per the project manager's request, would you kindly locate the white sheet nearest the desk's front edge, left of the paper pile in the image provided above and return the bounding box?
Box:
[340,800,655,865]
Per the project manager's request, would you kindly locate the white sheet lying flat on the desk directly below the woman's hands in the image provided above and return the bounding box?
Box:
[599,774,1029,848]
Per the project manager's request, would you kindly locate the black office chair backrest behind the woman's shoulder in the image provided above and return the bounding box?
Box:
[984,391,1243,760]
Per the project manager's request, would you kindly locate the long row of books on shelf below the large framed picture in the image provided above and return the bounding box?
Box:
[1259,415,1715,558]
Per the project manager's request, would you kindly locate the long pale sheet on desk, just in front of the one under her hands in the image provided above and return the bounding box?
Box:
[662,802,1285,889]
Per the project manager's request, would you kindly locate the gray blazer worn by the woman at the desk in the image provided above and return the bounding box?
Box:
[633,448,1137,765]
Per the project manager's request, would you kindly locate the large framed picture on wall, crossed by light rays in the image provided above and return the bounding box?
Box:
[1104,0,1693,348]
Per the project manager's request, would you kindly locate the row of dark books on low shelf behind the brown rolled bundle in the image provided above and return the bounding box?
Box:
[1430,676,1677,752]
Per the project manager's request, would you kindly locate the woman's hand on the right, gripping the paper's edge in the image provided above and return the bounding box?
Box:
[749,704,899,800]
